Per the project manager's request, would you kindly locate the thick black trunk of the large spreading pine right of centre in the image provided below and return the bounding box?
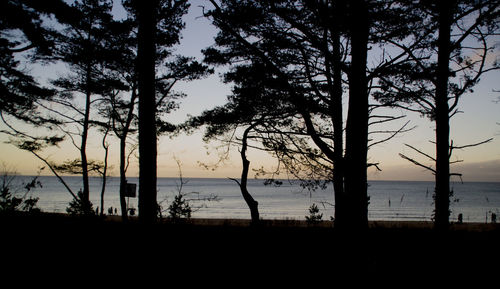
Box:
[345,0,369,229]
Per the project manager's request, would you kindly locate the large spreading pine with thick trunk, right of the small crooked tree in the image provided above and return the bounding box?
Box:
[205,1,414,228]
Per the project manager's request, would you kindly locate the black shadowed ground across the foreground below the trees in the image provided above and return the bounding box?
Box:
[0,214,500,288]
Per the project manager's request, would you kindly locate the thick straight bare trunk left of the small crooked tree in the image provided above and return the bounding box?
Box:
[137,1,157,223]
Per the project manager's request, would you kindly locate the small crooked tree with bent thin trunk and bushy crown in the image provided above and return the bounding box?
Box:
[181,65,295,224]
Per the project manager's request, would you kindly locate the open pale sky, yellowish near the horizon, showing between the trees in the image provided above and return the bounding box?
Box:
[0,0,500,182]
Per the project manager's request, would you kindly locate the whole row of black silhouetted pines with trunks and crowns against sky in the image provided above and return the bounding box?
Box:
[0,0,500,229]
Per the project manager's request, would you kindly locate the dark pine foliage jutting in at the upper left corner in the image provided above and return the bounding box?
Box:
[0,0,74,126]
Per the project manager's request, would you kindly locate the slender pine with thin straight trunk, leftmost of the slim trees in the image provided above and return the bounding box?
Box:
[47,0,117,212]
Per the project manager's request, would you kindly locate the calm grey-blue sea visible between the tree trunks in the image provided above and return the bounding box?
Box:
[4,176,500,223]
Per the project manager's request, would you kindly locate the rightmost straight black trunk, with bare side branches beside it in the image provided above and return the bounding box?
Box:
[434,0,454,230]
